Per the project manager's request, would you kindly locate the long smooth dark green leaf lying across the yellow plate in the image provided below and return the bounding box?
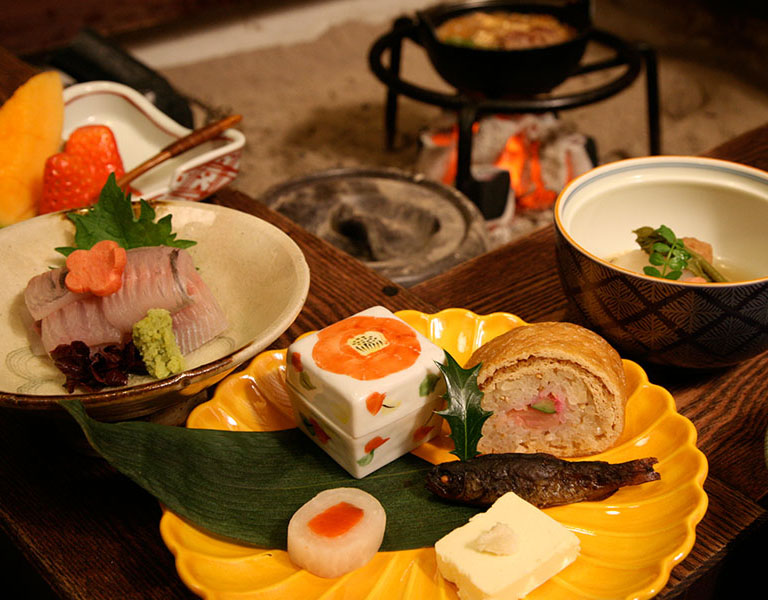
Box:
[61,399,478,551]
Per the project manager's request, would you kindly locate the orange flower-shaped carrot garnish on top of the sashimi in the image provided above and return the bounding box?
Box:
[64,240,127,296]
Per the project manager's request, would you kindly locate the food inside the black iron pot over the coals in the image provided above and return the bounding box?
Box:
[437,11,576,50]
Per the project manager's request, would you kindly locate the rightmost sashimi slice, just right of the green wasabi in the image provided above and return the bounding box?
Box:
[173,272,228,354]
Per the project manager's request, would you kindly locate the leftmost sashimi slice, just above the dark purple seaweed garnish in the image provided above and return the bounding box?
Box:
[40,296,125,353]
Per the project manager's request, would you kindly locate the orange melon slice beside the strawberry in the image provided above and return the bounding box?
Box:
[0,71,64,226]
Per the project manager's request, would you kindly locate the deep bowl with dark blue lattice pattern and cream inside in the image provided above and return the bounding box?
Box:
[554,156,768,368]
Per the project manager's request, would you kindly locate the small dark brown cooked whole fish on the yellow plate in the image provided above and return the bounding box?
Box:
[426,453,661,508]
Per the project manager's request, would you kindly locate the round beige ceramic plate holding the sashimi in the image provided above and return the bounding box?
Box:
[0,201,309,420]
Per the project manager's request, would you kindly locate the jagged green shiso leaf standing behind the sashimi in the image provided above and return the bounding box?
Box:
[56,173,196,256]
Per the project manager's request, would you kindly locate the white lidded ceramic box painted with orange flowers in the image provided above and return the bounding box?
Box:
[286,306,445,478]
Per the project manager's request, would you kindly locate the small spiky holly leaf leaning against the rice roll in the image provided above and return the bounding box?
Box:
[436,352,493,460]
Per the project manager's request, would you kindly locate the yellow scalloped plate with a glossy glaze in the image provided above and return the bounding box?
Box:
[160,309,707,600]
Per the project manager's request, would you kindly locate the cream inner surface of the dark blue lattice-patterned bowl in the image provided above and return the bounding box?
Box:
[558,156,768,279]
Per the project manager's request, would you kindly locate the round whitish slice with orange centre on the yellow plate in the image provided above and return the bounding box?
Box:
[288,488,387,577]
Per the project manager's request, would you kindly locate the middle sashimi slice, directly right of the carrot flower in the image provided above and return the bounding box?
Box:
[102,246,197,333]
